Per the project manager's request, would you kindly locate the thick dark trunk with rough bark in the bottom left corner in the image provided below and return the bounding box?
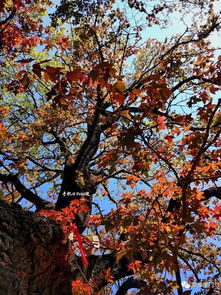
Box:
[0,201,71,295]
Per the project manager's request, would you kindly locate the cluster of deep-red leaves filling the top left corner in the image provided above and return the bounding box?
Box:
[0,0,50,57]
